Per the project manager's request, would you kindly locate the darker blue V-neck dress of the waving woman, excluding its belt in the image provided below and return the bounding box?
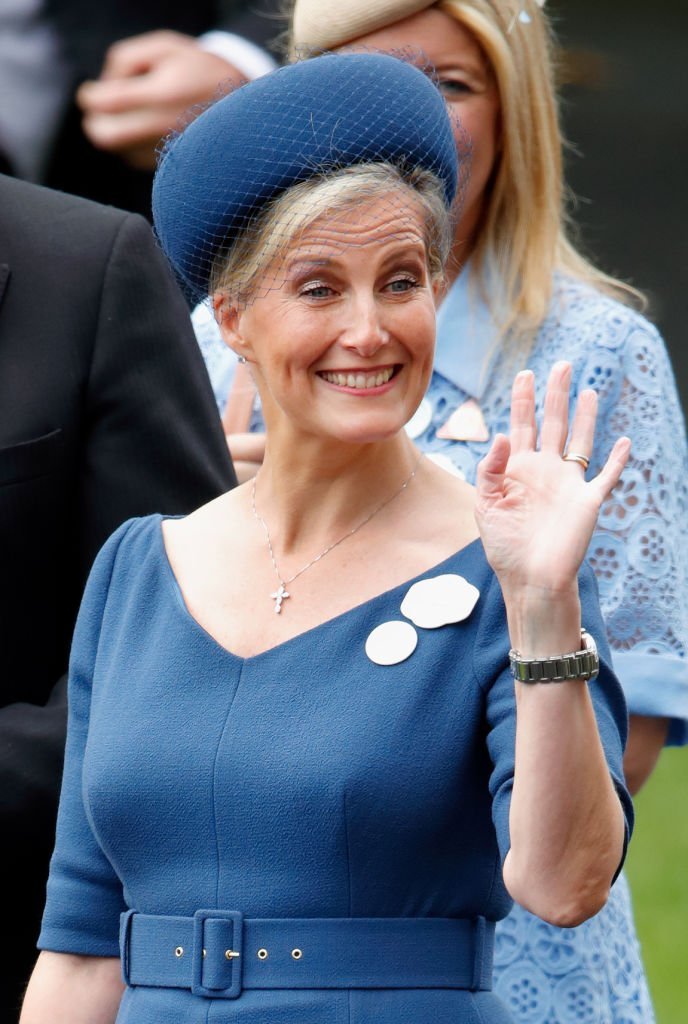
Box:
[39,516,632,1024]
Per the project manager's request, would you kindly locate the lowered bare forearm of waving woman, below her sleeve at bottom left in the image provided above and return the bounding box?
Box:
[19,951,124,1024]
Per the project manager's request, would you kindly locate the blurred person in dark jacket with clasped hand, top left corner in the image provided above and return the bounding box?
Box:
[0,0,280,216]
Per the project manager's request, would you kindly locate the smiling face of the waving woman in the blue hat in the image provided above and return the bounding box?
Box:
[215,194,435,443]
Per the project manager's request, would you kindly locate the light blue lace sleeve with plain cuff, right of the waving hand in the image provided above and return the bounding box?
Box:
[581,313,688,745]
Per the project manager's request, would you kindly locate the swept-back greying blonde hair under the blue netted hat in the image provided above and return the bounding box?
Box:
[209,163,452,306]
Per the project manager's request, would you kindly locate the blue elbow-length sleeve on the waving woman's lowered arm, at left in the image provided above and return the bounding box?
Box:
[38,520,135,956]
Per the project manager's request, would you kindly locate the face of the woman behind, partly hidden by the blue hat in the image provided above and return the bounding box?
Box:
[346,7,501,262]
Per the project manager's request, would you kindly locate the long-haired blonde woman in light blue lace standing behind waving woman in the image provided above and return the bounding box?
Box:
[195,0,688,1024]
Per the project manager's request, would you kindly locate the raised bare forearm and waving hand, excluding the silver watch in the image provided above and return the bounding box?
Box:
[476,364,630,927]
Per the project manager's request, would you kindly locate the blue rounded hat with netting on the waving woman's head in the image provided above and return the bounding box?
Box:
[153,53,458,302]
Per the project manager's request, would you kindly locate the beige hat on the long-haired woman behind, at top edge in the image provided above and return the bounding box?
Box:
[292,0,436,54]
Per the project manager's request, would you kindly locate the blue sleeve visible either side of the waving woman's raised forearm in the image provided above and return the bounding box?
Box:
[473,565,634,871]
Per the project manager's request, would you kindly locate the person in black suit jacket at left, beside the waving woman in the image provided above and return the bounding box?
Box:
[0,176,234,1022]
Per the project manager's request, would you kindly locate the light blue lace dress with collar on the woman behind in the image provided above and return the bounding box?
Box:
[192,272,688,1024]
